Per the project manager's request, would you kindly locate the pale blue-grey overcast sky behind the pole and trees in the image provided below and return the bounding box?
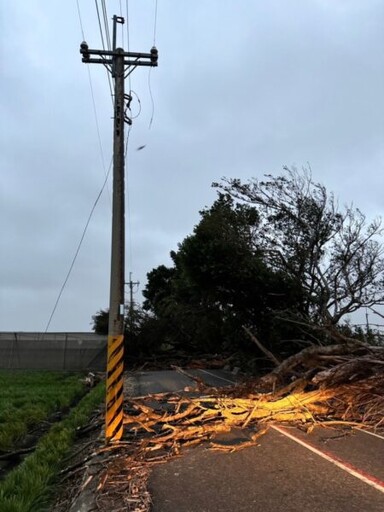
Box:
[0,0,384,331]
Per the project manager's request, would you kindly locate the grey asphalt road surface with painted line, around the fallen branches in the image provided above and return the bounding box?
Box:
[130,370,384,512]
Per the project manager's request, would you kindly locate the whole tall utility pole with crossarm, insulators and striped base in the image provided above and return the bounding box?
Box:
[80,15,158,442]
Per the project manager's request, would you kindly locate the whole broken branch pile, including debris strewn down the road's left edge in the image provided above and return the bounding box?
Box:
[94,343,384,512]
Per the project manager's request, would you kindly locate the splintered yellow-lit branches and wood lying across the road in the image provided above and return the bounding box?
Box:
[124,344,384,454]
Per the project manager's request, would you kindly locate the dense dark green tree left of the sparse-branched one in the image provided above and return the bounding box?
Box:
[143,194,300,352]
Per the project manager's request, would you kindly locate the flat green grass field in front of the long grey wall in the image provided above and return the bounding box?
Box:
[0,371,87,450]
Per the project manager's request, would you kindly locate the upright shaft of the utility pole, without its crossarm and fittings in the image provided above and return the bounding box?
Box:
[105,48,125,441]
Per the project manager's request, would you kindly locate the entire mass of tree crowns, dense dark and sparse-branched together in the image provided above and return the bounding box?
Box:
[94,168,384,362]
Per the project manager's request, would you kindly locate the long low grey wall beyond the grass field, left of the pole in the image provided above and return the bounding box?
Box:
[0,332,107,371]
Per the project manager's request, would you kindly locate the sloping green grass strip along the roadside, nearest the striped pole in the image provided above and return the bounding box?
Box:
[0,383,105,512]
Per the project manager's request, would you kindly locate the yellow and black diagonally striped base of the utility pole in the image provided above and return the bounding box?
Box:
[105,335,124,442]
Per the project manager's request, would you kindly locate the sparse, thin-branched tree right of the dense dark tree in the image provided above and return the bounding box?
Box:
[214,168,384,336]
